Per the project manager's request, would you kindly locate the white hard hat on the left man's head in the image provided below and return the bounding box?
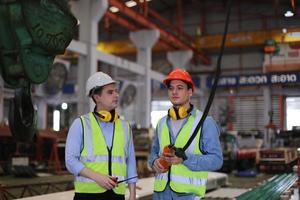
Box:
[85,72,116,96]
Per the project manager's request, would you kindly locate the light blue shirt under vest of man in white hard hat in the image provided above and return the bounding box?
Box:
[65,117,137,183]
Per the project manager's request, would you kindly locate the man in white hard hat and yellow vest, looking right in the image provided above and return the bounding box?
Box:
[65,72,137,200]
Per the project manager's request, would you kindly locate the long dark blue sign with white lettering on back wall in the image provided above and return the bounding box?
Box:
[206,71,300,88]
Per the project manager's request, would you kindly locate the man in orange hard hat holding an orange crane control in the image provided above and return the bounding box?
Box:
[148,68,223,200]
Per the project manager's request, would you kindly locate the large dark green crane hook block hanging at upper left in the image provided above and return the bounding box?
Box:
[0,0,77,141]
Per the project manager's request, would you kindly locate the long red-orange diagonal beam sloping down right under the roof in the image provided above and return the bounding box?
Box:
[109,0,211,64]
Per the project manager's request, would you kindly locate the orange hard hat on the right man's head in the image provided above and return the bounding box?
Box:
[163,68,195,92]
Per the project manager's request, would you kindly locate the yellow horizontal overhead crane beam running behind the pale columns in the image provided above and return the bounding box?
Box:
[98,28,300,54]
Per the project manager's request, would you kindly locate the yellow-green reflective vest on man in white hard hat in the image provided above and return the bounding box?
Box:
[74,112,130,195]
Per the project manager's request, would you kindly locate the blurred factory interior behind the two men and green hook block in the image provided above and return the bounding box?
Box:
[0,0,300,200]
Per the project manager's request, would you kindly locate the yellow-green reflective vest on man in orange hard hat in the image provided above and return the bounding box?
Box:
[154,110,208,197]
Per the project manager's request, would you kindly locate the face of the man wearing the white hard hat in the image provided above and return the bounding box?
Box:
[94,83,119,111]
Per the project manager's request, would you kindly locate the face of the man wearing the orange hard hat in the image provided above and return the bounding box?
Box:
[168,80,192,106]
